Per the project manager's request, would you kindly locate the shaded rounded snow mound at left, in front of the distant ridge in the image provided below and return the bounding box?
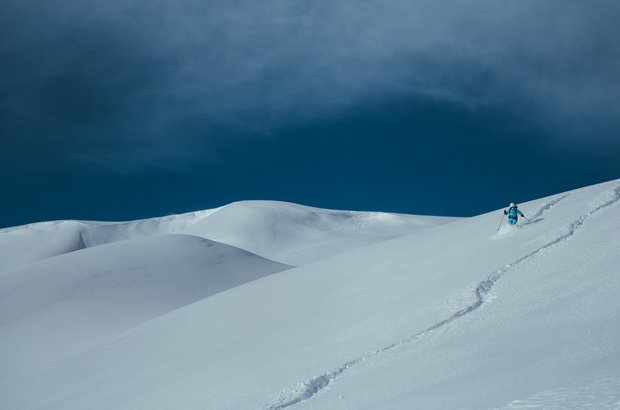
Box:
[0,235,289,384]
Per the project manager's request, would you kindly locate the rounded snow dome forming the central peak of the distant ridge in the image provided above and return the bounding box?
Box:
[179,201,455,265]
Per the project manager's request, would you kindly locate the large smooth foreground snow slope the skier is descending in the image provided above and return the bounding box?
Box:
[0,180,620,410]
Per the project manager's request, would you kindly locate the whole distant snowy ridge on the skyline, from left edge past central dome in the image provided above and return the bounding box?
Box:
[0,201,455,269]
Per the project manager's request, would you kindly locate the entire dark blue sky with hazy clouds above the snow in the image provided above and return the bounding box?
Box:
[0,0,620,226]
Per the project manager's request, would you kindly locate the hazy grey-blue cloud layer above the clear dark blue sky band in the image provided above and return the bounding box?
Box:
[0,0,620,167]
